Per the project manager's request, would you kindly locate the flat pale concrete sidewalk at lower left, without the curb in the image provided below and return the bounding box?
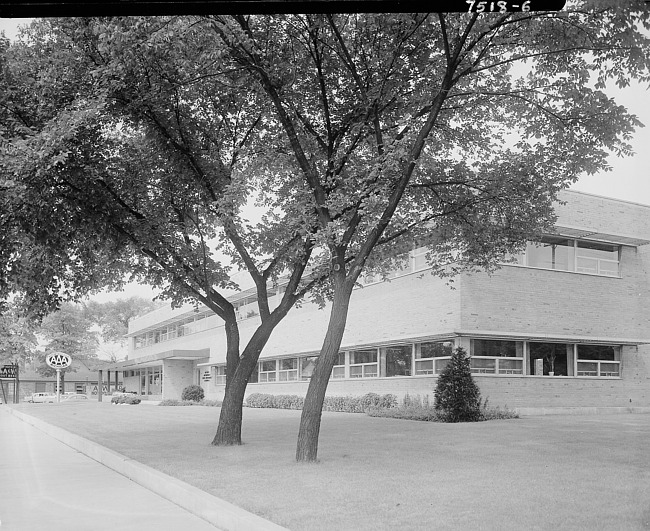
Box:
[0,406,217,531]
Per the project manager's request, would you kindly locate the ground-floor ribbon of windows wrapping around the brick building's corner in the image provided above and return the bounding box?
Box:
[210,337,621,387]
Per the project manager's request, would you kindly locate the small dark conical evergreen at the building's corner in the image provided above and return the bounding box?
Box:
[434,347,481,422]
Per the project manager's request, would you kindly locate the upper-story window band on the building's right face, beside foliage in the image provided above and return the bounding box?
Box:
[516,236,621,277]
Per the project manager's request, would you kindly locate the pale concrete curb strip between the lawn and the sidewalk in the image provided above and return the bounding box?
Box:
[6,407,288,531]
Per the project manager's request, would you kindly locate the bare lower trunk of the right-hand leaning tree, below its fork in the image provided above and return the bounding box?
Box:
[296,282,354,462]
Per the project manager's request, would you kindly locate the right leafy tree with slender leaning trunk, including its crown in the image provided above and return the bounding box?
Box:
[204,5,649,461]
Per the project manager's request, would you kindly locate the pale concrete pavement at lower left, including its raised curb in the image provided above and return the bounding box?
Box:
[0,407,283,531]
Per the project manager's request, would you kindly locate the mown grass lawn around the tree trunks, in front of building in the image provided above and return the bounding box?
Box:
[15,402,650,531]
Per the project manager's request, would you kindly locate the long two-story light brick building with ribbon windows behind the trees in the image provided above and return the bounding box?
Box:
[102,191,650,409]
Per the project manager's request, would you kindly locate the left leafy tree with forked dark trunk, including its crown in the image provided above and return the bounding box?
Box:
[1,18,320,444]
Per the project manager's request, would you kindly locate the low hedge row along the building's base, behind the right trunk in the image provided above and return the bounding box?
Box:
[246,393,397,413]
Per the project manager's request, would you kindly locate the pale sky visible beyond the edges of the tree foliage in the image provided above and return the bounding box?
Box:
[0,14,650,306]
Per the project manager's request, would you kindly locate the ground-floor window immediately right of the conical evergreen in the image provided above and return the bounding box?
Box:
[470,339,524,374]
